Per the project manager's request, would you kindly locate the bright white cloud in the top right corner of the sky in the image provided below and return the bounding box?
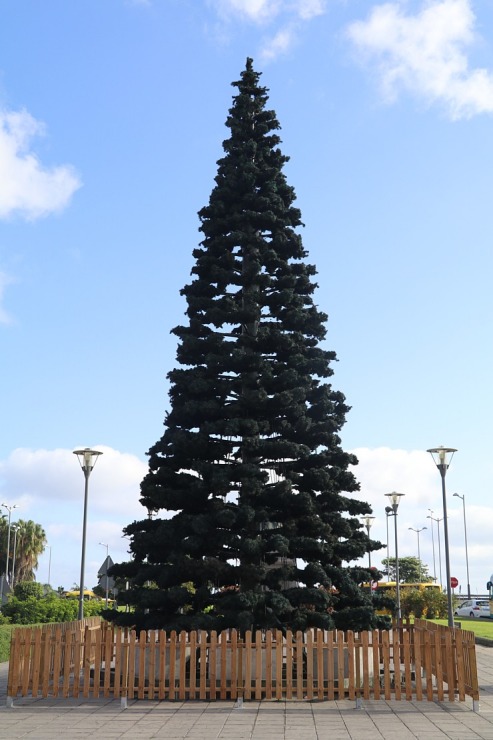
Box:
[348,0,493,119]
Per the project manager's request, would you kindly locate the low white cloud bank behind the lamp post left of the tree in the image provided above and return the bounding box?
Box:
[0,445,148,588]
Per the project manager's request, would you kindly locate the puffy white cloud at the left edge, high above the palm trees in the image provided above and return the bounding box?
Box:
[0,110,81,219]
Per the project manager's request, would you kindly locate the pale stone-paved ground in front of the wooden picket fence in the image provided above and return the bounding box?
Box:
[0,645,493,740]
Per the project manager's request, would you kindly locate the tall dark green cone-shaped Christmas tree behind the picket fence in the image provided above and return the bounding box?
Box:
[108,59,381,630]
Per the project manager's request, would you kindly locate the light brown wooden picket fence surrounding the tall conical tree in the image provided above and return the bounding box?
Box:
[7,618,479,706]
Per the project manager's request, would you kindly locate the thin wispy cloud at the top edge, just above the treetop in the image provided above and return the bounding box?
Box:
[209,0,327,60]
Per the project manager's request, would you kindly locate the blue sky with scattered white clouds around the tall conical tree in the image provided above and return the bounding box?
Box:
[0,0,493,591]
